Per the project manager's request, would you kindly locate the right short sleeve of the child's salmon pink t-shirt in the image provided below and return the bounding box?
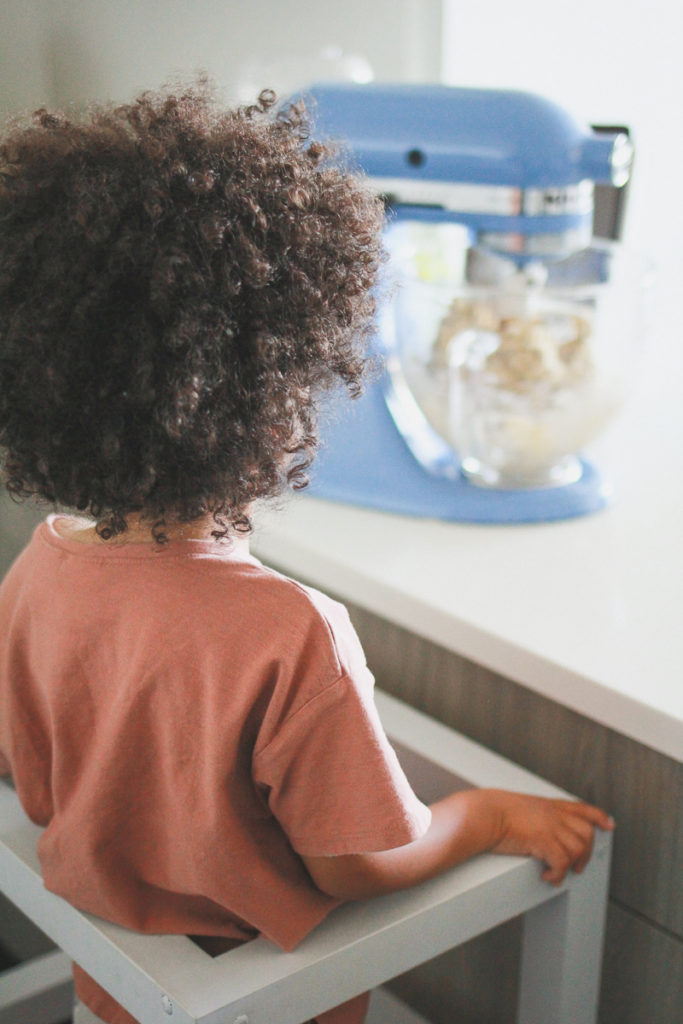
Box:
[254,669,431,857]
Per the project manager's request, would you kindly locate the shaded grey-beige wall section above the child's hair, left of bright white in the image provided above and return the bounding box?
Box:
[0,0,441,115]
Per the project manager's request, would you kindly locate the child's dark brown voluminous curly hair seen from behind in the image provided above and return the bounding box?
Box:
[0,82,384,540]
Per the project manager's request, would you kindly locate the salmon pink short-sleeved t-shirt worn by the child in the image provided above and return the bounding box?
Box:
[0,516,430,1024]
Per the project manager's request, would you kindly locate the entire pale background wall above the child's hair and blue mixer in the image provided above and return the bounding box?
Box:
[0,0,671,315]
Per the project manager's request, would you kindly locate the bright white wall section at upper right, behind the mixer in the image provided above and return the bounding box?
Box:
[442,0,683,347]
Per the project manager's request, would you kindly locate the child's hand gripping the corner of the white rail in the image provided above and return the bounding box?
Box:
[489,791,614,885]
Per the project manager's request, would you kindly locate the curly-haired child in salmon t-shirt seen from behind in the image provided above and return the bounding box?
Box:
[0,85,611,1024]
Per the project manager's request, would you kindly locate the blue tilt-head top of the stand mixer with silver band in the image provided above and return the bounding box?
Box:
[308,84,633,261]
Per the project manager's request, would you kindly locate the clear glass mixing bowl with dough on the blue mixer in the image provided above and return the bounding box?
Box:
[387,229,643,488]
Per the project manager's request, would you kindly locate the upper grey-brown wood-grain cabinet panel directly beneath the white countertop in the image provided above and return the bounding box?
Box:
[349,606,683,937]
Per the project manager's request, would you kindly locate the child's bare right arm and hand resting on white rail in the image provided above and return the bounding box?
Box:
[303,790,613,899]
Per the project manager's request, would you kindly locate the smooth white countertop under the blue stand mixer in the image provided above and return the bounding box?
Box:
[253,292,683,761]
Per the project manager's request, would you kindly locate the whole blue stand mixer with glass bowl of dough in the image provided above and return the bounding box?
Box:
[306,84,642,522]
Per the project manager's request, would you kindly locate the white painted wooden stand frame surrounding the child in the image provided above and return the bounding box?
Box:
[0,692,611,1024]
